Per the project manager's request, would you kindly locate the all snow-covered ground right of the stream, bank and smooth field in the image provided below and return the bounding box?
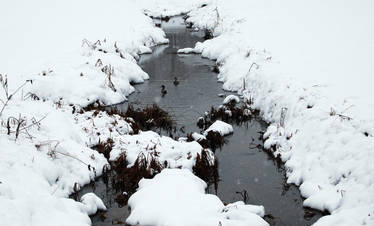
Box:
[142,0,374,225]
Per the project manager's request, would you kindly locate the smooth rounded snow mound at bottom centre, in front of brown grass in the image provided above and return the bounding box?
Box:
[126,169,268,226]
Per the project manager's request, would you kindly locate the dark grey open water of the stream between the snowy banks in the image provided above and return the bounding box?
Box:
[81,17,321,226]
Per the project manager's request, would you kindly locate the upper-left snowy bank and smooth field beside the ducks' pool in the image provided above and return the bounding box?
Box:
[0,0,168,106]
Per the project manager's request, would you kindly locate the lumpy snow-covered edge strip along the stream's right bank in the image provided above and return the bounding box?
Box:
[170,4,374,225]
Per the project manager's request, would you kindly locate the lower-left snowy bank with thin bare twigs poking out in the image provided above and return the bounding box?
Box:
[0,101,107,225]
